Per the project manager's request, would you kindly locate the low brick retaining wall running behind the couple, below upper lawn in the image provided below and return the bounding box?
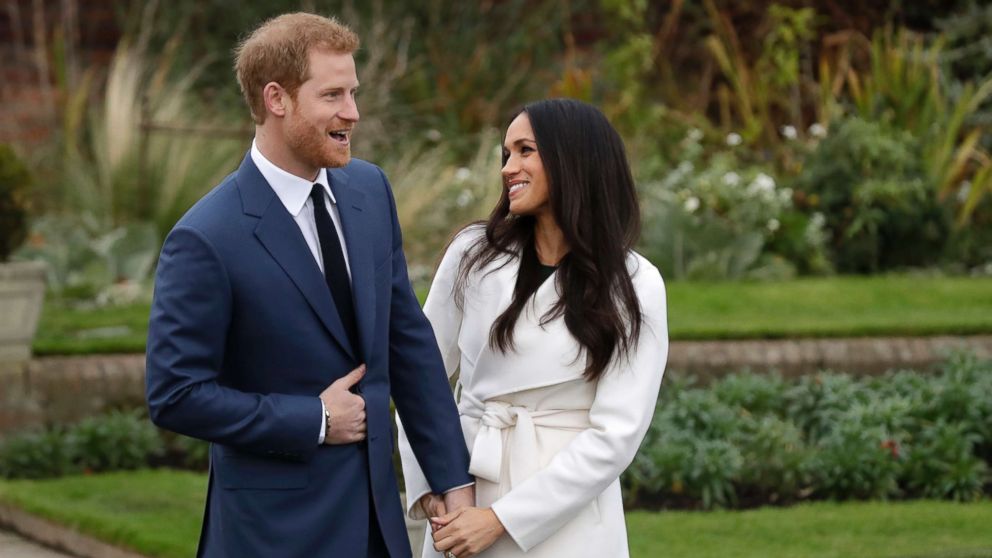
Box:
[0,335,992,436]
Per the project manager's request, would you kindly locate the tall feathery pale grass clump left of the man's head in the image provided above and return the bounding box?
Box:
[37,2,248,241]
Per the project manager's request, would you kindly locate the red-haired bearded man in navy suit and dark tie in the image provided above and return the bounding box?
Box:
[147,14,473,558]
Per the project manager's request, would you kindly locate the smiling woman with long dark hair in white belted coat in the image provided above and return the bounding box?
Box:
[400,99,668,558]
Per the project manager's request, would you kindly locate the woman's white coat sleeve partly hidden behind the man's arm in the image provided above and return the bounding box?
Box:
[396,228,476,519]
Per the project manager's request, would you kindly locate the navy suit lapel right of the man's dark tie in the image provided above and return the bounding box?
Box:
[327,169,375,366]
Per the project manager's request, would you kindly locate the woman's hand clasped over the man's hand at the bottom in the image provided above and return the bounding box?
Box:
[431,507,506,558]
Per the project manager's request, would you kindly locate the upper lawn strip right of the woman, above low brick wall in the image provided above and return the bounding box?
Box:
[668,275,992,339]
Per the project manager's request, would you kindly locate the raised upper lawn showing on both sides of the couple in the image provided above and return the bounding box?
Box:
[34,275,992,355]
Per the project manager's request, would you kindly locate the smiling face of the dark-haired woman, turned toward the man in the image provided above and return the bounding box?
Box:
[502,112,551,216]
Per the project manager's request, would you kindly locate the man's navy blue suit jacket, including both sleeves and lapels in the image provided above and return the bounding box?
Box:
[146,156,472,558]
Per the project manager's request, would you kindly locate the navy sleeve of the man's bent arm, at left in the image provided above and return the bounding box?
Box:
[145,226,321,460]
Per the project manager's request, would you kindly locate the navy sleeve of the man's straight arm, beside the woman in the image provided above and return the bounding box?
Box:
[383,172,472,516]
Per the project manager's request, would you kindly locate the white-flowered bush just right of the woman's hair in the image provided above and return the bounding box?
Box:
[640,129,825,279]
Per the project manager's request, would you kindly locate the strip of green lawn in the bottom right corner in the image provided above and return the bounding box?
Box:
[627,501,992,558]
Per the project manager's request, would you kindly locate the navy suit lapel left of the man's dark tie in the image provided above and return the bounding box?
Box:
[237,155,354,357]
